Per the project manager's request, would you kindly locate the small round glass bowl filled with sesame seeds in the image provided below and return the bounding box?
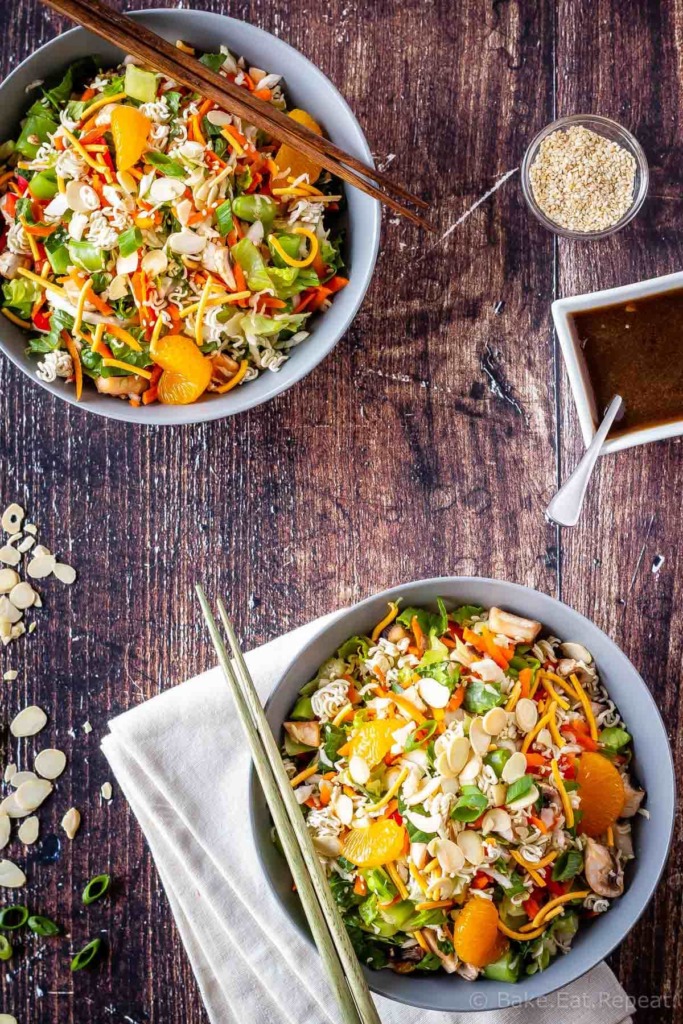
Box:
[521,114,649,239]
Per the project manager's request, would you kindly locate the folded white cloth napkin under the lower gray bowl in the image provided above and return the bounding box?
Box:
[102,616,631,1024]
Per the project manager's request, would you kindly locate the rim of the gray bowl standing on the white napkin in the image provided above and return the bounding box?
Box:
[248,577,677,1013]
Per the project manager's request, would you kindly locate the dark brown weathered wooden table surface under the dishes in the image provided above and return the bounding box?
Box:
[0,0,683,1024]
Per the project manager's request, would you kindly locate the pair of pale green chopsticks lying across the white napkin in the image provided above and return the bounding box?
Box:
[196,585,381,1024]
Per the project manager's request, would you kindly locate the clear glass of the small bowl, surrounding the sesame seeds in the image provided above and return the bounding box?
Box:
[521,114,650,239]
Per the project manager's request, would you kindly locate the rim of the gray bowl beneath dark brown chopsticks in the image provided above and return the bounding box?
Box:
[0,7,382,427]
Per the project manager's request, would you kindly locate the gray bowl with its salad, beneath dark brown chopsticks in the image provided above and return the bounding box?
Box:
[0,10,380,424]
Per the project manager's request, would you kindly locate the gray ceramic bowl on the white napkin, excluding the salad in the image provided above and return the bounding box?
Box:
[250,577,676,1011]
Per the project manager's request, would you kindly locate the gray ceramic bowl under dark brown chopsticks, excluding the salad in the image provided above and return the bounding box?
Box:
[0,10,380,424]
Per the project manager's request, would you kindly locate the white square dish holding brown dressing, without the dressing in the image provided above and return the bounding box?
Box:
[552,272,683,455]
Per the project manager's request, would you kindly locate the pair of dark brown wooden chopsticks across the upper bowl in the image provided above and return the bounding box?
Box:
[41,0,435,231]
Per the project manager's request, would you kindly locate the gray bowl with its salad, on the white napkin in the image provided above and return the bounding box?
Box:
[250,578,676,1012]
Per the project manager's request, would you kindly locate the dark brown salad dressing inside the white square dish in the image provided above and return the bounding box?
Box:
[571,288,683,436]
